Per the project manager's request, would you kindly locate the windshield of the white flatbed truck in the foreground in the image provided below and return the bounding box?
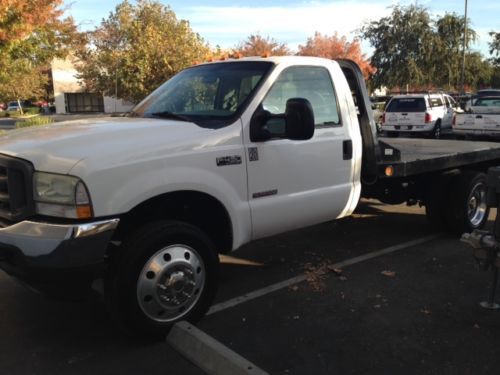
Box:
[133,61,273,128]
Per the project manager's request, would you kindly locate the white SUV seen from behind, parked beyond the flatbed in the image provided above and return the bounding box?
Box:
[382,93,457,139]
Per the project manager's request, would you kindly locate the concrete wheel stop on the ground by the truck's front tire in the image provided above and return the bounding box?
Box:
[167,321,268,375]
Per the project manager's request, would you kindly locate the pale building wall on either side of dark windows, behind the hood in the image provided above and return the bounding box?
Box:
[51,58,134,113]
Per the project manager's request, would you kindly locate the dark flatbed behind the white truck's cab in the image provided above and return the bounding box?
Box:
[379,138,500,177]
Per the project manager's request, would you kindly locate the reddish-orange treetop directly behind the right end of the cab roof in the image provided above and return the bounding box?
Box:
[297,32,375,79]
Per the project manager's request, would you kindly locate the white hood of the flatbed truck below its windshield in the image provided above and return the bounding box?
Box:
[0,117,214,174]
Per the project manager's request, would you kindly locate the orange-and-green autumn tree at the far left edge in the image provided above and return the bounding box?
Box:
[0,0,81,100]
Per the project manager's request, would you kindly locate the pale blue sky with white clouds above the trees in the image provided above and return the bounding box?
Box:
[65,0,500,57]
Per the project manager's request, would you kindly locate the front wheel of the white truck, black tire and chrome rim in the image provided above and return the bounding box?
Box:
[105,221,218,338]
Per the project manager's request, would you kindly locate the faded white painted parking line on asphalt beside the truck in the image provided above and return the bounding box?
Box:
[207,234,441,315]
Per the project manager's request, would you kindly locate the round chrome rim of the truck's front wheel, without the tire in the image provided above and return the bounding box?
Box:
[137,245,205,322]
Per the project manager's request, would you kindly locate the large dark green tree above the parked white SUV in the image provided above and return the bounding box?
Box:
[360,5,491,90]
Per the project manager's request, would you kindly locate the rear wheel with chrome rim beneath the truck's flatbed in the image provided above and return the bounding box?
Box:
[446,171,489,235]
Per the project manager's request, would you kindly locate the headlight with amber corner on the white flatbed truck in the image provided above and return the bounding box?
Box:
[33,172,93,219]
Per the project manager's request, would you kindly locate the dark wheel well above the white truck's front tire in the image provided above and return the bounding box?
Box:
[113,191,233,253]
